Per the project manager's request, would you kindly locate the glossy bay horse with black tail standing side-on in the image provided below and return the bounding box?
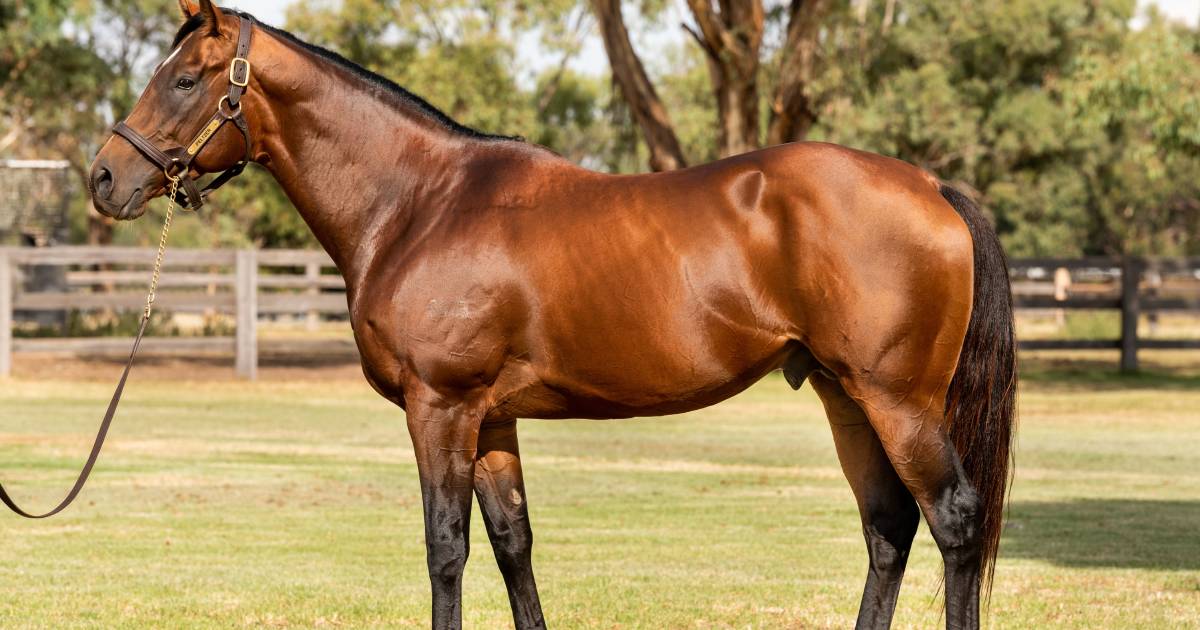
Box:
[90,0,1016,629]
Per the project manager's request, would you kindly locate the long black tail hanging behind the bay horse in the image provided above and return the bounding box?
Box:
[941,185,1016,593]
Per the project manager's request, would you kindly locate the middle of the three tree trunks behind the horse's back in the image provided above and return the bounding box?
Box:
[688,0,763,157]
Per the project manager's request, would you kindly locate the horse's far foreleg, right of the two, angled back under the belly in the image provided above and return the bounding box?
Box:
[475,420,546,630]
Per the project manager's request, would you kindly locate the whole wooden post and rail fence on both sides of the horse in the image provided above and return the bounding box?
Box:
[0,246,1200,379]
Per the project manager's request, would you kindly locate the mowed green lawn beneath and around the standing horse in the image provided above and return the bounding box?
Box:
[0,355,1200,629]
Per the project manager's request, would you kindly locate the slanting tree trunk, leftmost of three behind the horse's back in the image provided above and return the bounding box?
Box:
[590,0,688,170]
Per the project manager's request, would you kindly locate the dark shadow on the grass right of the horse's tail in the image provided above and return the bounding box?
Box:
[1001,499,1200,571]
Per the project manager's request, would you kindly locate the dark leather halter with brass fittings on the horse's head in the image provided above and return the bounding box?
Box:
[113,16,254,210]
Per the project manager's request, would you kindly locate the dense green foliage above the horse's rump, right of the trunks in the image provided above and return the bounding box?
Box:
[815,0,1200,256]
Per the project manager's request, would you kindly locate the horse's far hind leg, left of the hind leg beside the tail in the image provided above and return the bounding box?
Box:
[810,372,920,630]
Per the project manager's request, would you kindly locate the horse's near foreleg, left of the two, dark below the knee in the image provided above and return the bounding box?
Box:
[408,403,481,630]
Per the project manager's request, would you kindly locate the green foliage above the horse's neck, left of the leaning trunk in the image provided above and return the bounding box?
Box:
[288,0,631,169]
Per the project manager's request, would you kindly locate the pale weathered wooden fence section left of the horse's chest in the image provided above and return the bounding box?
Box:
[0,246,347,379]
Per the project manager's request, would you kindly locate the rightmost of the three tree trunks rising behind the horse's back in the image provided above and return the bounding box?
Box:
[767,0,830,144]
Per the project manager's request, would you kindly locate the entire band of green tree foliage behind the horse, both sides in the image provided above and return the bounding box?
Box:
[0,0,1200,256]
